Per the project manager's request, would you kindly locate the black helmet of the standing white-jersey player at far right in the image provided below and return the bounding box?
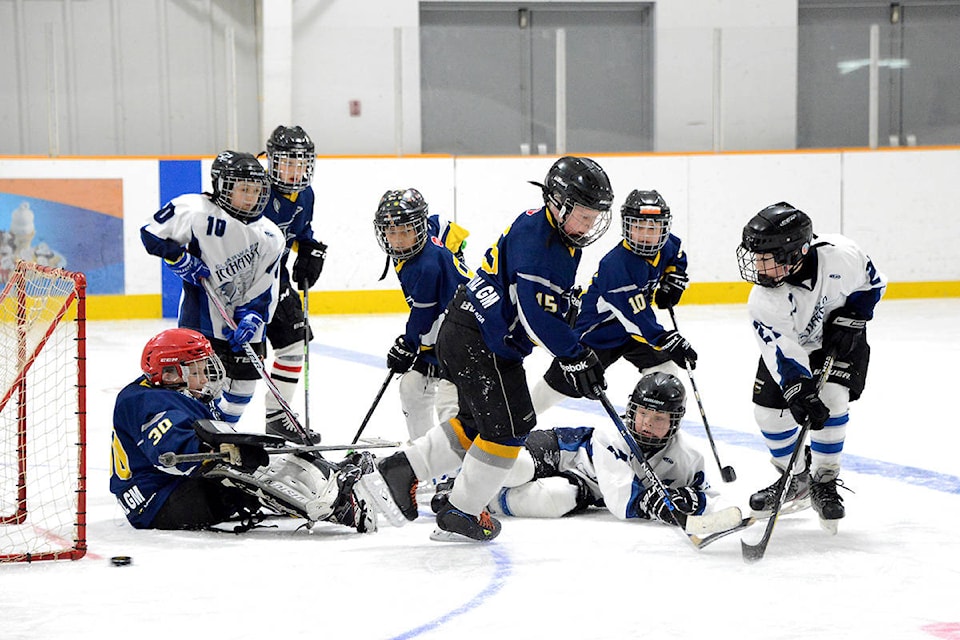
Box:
[737,202,813,287]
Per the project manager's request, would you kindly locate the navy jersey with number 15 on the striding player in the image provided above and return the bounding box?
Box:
[467,207,582,360]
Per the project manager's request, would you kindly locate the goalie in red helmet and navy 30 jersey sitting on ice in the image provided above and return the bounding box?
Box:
[110,328,377,533]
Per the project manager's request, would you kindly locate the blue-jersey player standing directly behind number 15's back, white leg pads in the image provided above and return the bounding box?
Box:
[373,189,473,440]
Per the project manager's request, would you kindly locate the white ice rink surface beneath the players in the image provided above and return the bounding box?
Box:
[0,300,960,640]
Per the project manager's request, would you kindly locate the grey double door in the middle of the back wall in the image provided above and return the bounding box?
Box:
[420,3,653,155]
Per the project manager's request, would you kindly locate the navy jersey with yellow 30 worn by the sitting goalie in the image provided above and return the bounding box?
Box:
[110,376,218,529]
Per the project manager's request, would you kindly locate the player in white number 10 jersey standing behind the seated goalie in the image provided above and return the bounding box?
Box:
[140,151,284,424]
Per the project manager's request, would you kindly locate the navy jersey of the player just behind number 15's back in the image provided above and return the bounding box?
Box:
[394,236,473,365]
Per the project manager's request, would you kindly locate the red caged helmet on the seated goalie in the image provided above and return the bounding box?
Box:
[140,328,226,402]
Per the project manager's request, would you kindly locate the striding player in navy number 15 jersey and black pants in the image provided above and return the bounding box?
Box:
[368,156,613,541]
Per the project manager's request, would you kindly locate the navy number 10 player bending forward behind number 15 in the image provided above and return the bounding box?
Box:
[531,190,697,414]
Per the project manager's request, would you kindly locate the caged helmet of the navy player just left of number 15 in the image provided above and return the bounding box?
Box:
[373,189,429,260]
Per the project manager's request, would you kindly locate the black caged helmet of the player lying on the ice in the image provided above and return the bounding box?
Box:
[626,371,687,452]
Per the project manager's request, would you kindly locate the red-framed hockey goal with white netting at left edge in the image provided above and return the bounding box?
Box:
[0,262,87,562]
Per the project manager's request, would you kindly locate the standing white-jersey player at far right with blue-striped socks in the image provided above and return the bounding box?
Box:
[737,202,887,530]
